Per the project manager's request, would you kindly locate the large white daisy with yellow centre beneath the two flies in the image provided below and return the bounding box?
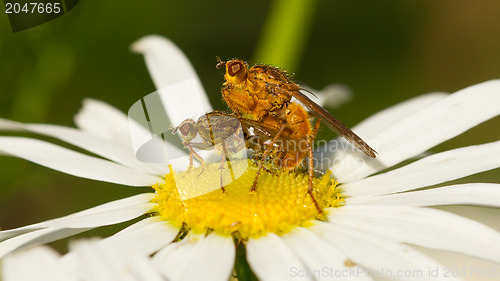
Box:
[0,36,500,280]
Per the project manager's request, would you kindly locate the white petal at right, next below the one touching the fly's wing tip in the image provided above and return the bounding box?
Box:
[342,141,500,196]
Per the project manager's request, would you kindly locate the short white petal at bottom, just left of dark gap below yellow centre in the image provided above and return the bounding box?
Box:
[153,234,236,281]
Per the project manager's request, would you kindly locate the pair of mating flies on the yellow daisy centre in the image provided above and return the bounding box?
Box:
[174,59,376,212]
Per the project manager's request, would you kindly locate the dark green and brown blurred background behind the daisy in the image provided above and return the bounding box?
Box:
[0,0,500,253]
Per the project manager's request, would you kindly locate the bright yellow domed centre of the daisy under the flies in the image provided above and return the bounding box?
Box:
[153,160,343,239]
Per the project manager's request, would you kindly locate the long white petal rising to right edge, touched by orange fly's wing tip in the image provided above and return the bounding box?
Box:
[332,80,500,182]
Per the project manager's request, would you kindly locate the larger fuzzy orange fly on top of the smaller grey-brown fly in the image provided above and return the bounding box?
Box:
[217,59,376,212]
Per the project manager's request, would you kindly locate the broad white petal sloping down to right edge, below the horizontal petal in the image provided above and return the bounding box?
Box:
[329,205,500,262]
